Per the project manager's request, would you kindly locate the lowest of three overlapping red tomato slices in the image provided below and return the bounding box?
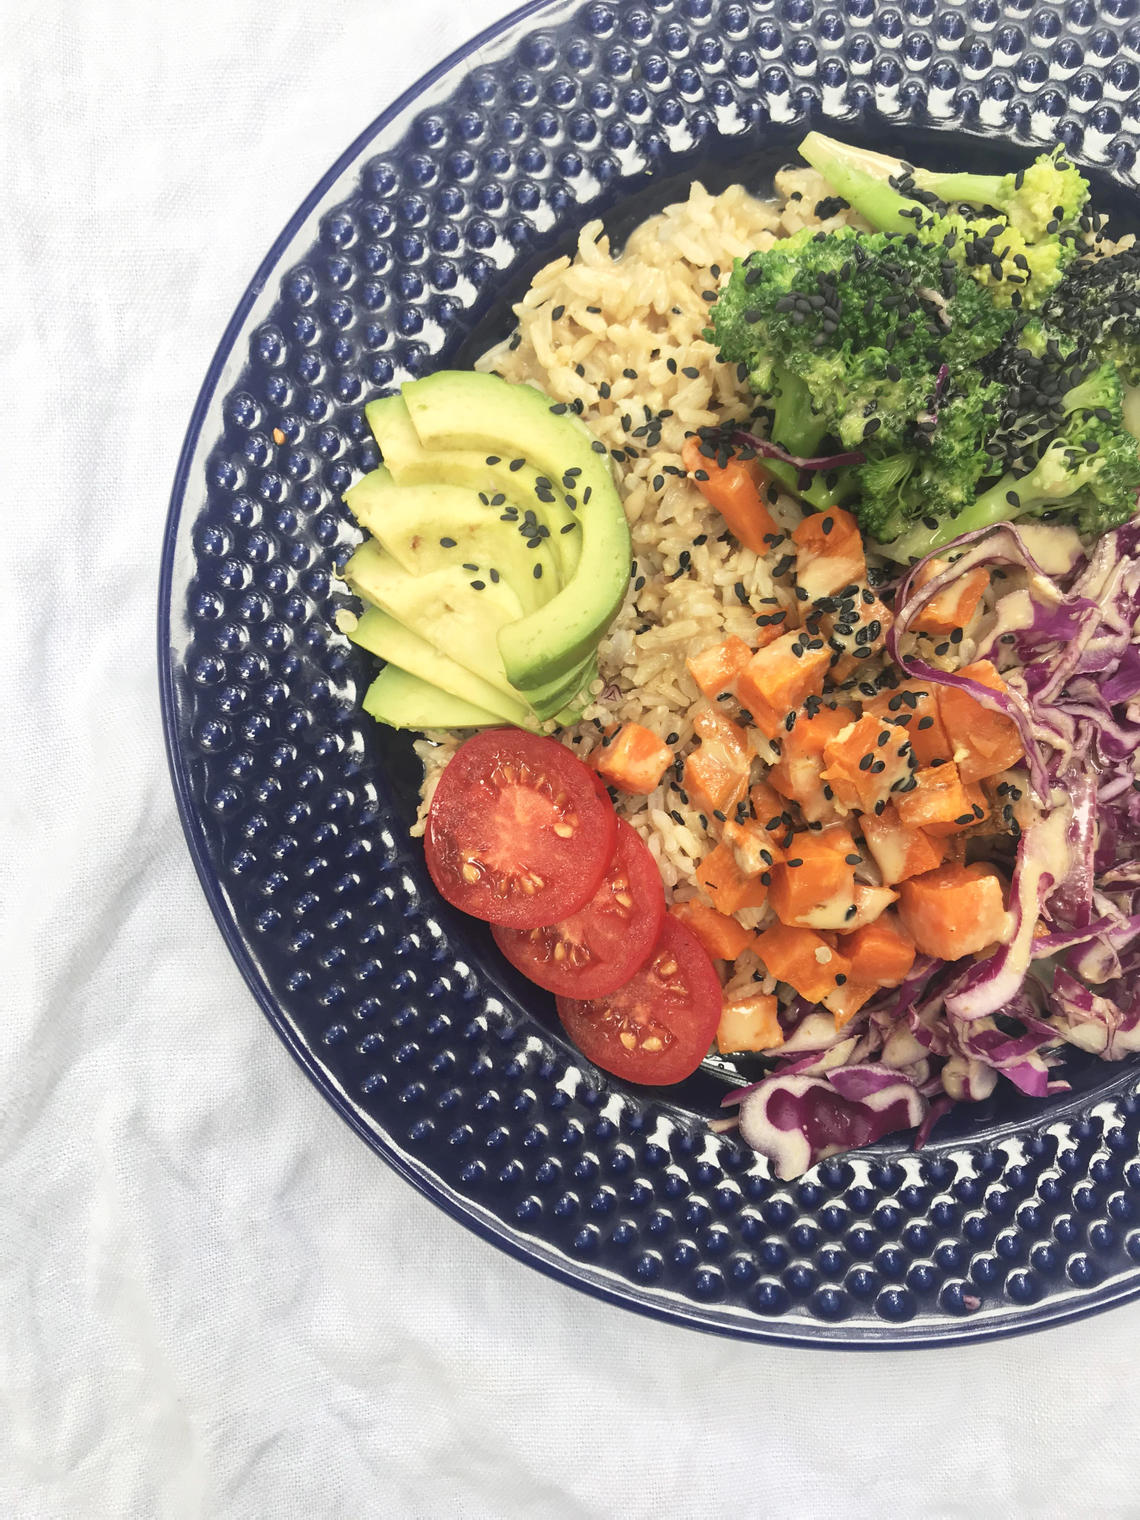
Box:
[558,914,720,1087]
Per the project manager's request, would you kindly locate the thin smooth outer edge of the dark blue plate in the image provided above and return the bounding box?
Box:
[157,0,1140,1351]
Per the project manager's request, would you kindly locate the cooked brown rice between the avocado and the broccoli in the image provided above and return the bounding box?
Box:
[415,169,862,980]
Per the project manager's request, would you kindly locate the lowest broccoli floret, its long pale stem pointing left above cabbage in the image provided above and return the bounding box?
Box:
[886,376,1140,561]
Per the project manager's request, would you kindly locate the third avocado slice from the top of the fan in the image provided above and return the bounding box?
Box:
[345,467,561,614]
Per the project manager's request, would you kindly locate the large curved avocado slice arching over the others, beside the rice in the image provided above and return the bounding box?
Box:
[401,369,631,690]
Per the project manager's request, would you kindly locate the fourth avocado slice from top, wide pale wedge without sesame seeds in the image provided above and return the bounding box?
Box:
[340,538,523,696]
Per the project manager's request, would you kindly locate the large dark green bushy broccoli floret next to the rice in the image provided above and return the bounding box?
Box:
[711,214,1014,537]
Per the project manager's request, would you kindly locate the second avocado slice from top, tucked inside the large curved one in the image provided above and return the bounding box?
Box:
[365,382,582,584]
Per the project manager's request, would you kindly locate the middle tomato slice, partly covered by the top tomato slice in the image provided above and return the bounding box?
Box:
[491,818,664,997]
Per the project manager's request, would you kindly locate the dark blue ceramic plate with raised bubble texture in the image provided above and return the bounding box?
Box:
[160,0,1140,1345]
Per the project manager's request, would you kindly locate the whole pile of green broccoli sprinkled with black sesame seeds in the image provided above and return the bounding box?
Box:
[707,132,1140,559]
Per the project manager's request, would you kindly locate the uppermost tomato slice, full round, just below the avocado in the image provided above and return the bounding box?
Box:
[424,728,617,929]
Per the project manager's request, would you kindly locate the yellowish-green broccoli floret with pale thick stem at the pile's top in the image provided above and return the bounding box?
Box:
[800,132,1088,309]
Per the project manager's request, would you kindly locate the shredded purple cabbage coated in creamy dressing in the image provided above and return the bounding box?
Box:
[725,519,1140,1178]
